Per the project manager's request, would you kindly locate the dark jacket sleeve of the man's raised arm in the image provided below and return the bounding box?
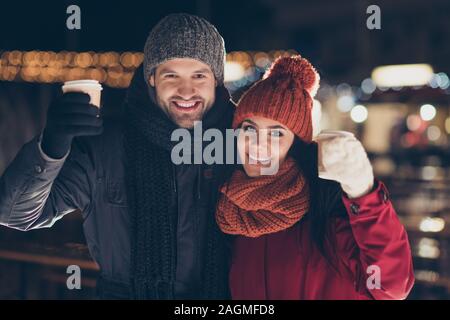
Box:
[0,134,95,231]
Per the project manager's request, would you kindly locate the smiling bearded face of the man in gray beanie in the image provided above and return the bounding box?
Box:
[149,58,216,128]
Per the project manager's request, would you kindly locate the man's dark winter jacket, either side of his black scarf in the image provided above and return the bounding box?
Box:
[0,68,234,298]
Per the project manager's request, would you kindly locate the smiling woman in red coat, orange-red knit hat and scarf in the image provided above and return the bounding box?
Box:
[216,56,414,299]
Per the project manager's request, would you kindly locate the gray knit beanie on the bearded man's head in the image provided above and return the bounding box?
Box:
[144,13,225,84]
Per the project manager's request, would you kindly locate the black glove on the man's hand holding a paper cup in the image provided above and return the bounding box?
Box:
[41,92,103,159]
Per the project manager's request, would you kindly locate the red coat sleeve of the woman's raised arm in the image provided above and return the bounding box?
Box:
[342,180,414,299]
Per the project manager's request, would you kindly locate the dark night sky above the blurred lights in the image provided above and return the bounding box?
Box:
[0,0,450,83]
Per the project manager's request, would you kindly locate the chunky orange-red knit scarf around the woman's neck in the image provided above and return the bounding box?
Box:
[216,158,309,237]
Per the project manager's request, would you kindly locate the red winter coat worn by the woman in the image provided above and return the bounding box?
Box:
[230,180,414,300]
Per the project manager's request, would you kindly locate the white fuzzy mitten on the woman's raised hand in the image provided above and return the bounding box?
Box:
[316,134,374,198]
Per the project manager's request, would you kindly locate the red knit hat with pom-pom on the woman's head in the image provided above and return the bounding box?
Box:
[233,55,319,143]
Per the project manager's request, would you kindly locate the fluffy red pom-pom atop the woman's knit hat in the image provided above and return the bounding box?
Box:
[263,55,320,98]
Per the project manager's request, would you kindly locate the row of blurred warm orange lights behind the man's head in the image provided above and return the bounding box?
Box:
[0,50,297,90]
